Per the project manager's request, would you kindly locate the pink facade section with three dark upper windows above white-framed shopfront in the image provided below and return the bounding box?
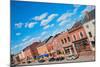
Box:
[59,31,77,56]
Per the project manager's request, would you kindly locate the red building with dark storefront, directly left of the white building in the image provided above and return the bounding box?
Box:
[68,21,90,53]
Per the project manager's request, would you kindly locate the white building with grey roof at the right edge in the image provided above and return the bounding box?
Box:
[83,9,96,51]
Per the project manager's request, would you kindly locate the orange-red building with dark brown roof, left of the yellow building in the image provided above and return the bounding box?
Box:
[23,42,40,62]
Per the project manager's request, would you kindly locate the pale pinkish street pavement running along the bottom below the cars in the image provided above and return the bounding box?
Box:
[18,52,95,66]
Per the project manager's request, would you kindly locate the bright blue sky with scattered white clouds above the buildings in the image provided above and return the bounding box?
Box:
[11,1,95,54]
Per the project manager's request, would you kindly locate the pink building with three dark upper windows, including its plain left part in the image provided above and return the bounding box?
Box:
[53,31,77,58]
